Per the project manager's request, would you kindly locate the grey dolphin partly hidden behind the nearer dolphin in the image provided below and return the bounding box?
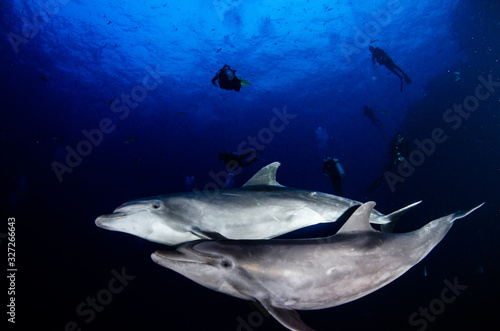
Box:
[95,162,420,245]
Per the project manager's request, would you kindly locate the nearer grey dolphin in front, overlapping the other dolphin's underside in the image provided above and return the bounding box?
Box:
[151,202,482,331]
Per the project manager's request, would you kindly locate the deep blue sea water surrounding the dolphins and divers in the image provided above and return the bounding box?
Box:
[0,0,500,330]
